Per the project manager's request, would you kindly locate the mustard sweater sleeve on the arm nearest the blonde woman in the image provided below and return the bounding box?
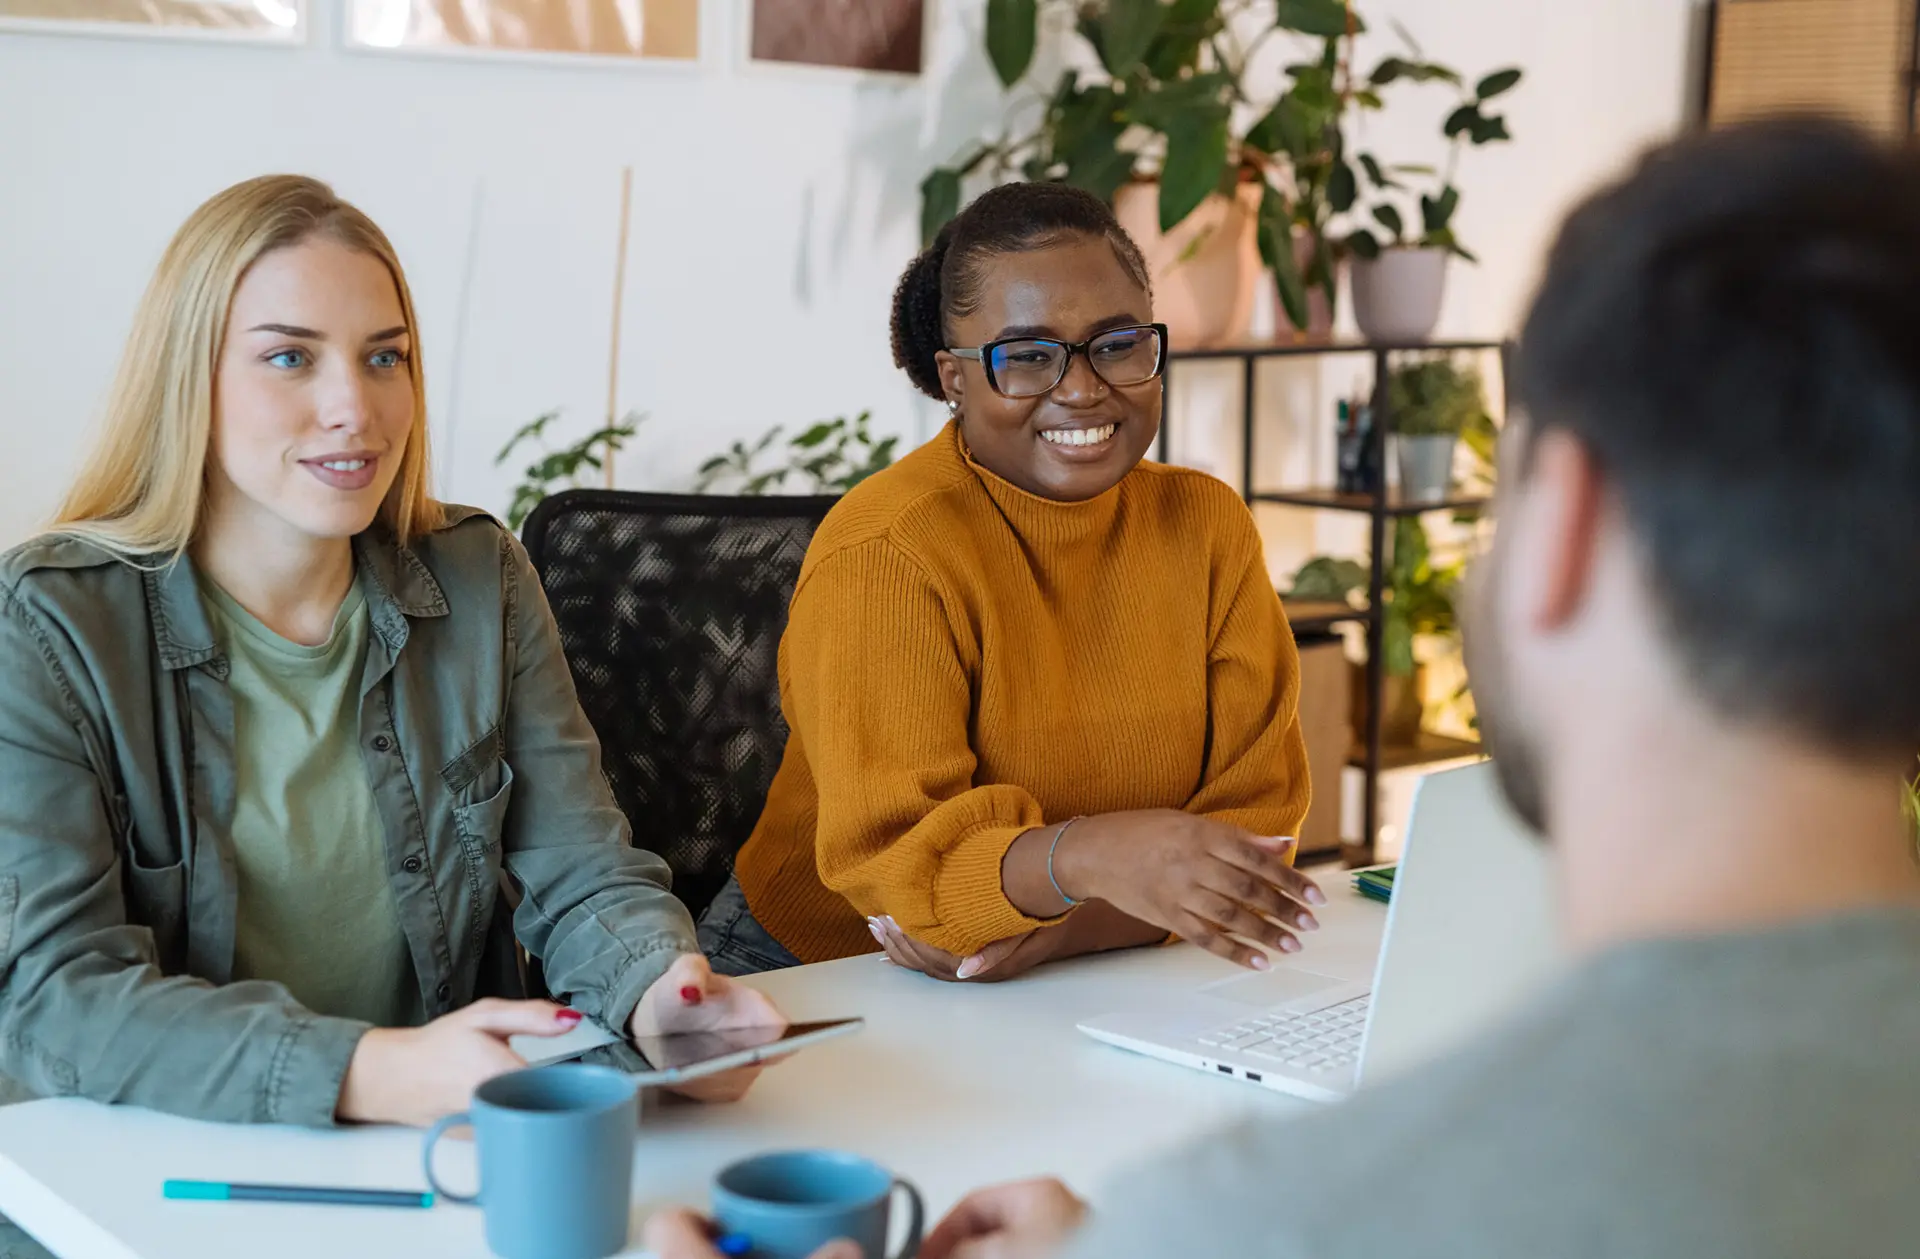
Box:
[781,539,1044,956]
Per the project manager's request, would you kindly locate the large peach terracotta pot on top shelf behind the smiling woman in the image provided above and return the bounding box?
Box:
[1114,180,1263,349]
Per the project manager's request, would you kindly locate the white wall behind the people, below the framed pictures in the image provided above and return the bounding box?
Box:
[0,0,1688,545]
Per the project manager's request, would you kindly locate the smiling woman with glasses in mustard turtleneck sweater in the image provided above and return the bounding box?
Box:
[701,184,1323,981]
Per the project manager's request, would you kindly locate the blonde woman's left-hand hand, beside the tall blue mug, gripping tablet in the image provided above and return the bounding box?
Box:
[334,998,580,1127]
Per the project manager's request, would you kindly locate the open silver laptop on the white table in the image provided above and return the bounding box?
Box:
[1079,762,1559,1102]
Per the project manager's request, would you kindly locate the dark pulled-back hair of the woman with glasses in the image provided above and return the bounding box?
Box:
[893,184,1152,399]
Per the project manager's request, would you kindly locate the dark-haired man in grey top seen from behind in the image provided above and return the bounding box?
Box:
[652,121,1920,1259]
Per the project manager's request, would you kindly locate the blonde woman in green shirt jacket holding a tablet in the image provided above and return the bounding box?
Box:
[0,177,780,1125]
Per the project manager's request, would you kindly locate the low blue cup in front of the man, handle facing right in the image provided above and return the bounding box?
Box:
[714,1150,925,1259]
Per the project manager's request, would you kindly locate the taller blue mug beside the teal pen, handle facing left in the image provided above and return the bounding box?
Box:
[422,1063,639,1259]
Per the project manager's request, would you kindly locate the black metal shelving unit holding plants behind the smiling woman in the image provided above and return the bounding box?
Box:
[1158,340,1511,866]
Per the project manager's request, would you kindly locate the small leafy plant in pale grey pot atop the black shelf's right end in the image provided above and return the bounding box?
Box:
[1346,50,1521,344]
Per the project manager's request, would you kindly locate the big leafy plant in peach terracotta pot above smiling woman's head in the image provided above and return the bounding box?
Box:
[922,0,1365,345]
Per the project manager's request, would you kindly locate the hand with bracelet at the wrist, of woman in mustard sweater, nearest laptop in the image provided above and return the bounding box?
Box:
[1052,808,1327,971]
